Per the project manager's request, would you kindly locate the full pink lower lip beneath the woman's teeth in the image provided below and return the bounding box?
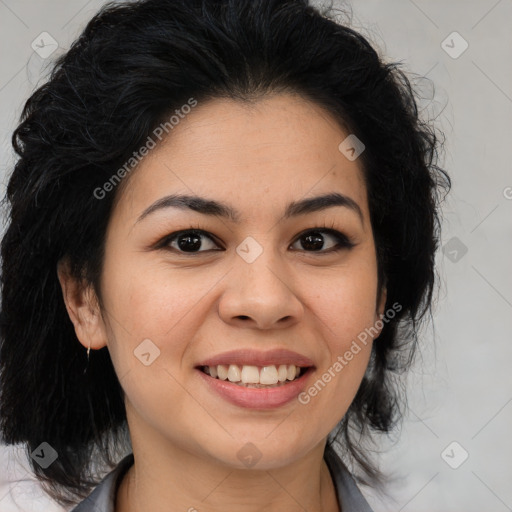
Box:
[197,367,314,409]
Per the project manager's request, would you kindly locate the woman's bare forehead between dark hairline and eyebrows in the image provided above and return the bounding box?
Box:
[113,94,368,226]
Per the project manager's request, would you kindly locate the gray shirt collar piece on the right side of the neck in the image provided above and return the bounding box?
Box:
[324,445,373,512]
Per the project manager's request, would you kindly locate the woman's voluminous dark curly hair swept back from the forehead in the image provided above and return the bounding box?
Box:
[0,0,450,505]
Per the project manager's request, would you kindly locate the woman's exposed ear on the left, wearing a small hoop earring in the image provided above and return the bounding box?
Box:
[57,258,107,350]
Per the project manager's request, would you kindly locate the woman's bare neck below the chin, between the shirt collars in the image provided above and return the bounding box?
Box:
[115,430,341,512]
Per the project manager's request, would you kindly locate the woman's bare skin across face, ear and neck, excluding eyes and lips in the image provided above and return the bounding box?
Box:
[59,94,385,512]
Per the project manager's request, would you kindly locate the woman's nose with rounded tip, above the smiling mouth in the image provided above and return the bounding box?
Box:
[219,245,304,329]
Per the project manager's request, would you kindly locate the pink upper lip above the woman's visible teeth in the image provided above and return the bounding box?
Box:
[198,349,314,367]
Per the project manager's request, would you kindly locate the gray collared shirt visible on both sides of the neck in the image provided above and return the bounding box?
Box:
[71,445,373,512]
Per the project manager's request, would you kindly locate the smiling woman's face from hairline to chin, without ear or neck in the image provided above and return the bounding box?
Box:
[87,95,381,468]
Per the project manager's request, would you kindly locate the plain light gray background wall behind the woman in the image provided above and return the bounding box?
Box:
[0,0,512,512]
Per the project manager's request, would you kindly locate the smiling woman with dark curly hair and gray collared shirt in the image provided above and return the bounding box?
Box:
[0,0,449,512]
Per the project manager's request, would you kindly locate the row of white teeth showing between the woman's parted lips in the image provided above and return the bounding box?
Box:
[198,364,309,389]
